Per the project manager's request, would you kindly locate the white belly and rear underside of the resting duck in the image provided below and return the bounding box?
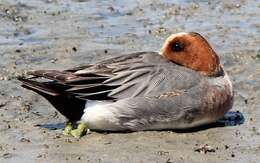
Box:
[81,100,218,131]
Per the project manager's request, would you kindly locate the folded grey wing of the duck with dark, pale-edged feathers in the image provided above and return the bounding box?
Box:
[20,52,201,100]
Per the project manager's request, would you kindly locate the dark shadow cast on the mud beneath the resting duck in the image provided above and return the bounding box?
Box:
[36,111,245,133]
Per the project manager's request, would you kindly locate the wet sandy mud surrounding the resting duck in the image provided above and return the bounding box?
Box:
[0,0,260,163]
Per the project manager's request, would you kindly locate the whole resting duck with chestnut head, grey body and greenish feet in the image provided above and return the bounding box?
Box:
[18,32,234,138]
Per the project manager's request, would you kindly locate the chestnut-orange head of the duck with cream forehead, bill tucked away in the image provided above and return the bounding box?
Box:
[160,32,221,76]
